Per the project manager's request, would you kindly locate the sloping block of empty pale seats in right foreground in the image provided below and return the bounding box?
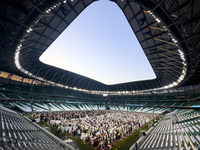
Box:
[140,111,200,150]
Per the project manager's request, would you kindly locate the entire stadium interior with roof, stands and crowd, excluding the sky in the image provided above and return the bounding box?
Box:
[0,0,200,150]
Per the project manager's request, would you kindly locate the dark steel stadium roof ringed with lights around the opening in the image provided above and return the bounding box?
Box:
[0,0,200,92]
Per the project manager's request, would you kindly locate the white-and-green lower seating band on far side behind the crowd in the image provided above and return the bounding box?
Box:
[0,102,169,114]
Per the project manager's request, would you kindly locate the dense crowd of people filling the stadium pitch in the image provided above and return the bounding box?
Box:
[34,110,158,147]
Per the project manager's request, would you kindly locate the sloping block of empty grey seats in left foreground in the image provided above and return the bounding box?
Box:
[0,106,67,150]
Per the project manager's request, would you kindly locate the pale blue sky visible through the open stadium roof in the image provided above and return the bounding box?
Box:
[40,0,156,85]
